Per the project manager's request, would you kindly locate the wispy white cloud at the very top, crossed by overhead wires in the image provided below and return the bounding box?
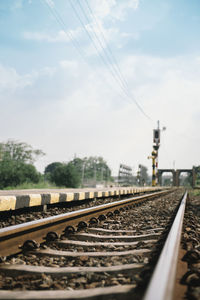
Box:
[23,0,139,55]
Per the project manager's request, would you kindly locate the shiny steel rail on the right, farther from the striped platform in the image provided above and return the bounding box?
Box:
[144,192,188,300]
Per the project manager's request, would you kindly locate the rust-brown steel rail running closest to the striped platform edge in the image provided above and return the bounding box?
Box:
[0,190,171,256]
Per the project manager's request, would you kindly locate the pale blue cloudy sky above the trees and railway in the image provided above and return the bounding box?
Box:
[0,0,200,175]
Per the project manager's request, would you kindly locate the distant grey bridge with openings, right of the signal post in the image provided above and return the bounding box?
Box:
[158,168,196,187]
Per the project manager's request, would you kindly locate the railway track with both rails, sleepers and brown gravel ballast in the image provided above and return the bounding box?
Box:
[0,191,194,300]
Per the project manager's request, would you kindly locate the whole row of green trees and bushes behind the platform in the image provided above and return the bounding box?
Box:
[0,140,111,189]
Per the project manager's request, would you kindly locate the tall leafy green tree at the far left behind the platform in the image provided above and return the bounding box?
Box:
[0,140,44,189]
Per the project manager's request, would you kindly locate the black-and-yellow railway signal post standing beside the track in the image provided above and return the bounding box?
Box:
[148,121,161,186]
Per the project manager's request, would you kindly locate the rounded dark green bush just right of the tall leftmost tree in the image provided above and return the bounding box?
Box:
[51,164,81,188]
